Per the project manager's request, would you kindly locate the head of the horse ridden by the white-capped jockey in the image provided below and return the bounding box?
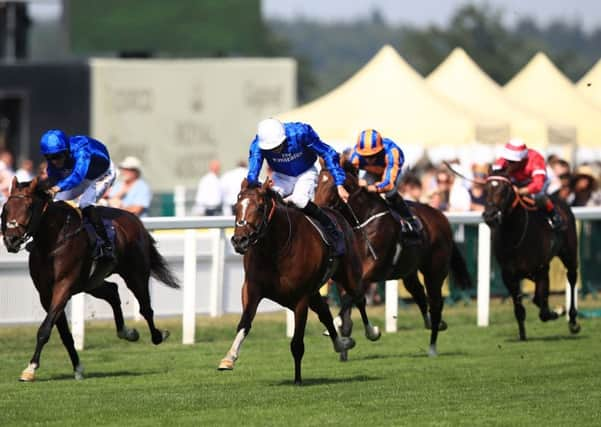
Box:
[232,178,277,254]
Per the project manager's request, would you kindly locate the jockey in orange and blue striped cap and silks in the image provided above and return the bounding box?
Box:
[350,129,422,237]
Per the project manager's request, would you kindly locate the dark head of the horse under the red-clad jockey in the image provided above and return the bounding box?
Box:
[482,171,519,227]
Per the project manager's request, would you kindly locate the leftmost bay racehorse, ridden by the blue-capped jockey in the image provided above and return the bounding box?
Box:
[2,178,179,381]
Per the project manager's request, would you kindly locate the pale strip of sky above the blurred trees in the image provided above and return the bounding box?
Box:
[262,0,601,31]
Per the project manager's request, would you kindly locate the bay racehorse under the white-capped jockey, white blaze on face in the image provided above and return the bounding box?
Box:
[218,179,380,384]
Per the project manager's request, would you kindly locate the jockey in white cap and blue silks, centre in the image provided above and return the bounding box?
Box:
[247,118,348,256]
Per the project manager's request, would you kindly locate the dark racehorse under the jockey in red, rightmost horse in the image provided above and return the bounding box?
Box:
[483,171,580,340]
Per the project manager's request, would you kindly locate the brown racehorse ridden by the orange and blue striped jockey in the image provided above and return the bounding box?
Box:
[315,161,472,360]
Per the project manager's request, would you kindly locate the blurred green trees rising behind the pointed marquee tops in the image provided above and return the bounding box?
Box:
[269,4,601,100]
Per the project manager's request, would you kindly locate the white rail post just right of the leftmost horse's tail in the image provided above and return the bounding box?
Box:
[182,230,196,344]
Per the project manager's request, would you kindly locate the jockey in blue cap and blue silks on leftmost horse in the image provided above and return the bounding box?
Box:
[40,130,116,260]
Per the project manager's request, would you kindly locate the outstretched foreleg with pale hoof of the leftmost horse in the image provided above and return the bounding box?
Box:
[19,281,70,382]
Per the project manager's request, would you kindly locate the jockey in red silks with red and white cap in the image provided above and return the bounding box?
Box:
[493,139,563,229]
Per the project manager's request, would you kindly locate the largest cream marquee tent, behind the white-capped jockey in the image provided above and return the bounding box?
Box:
[277,46,475,157]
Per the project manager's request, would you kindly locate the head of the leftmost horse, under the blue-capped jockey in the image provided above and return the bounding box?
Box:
[1,177,50,253]
